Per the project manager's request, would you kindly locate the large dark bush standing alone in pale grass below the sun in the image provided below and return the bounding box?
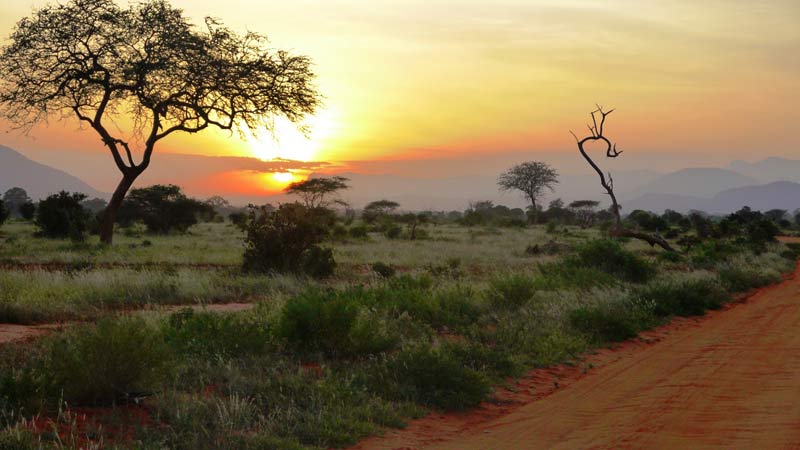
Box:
[244,203,336,275]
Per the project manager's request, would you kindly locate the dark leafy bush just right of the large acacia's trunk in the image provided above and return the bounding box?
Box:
[117,184,214,234]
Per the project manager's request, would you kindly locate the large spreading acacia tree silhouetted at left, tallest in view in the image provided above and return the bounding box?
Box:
[0,0,320,243]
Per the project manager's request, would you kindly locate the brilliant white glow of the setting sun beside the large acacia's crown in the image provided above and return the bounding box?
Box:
[249,110,333,163]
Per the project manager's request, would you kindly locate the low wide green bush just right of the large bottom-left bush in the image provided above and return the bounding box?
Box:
[164,308,271,356]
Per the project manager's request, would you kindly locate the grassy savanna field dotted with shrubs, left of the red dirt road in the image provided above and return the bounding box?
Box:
[0,222,795,450]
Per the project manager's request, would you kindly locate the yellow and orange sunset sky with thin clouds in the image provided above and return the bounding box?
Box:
[0,0,800,195]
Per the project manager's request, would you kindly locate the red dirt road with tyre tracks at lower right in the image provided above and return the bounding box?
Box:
[358,262,800,450]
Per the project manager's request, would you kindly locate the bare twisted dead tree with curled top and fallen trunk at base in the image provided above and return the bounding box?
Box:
[570,105,673,251]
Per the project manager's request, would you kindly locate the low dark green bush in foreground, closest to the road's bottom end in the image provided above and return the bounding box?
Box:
[384,347,491,410]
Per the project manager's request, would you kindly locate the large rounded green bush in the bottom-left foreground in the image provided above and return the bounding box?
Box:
[42,317,171,405]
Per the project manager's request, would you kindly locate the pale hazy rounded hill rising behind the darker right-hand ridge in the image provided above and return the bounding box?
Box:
[623,167,758,198]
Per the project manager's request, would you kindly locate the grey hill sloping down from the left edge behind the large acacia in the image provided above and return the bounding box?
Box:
[0,145,107,200]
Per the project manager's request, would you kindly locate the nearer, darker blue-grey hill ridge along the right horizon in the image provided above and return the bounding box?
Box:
[622,181,800,214]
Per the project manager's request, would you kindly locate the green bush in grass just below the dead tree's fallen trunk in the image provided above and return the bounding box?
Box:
[569,239,655,283]
